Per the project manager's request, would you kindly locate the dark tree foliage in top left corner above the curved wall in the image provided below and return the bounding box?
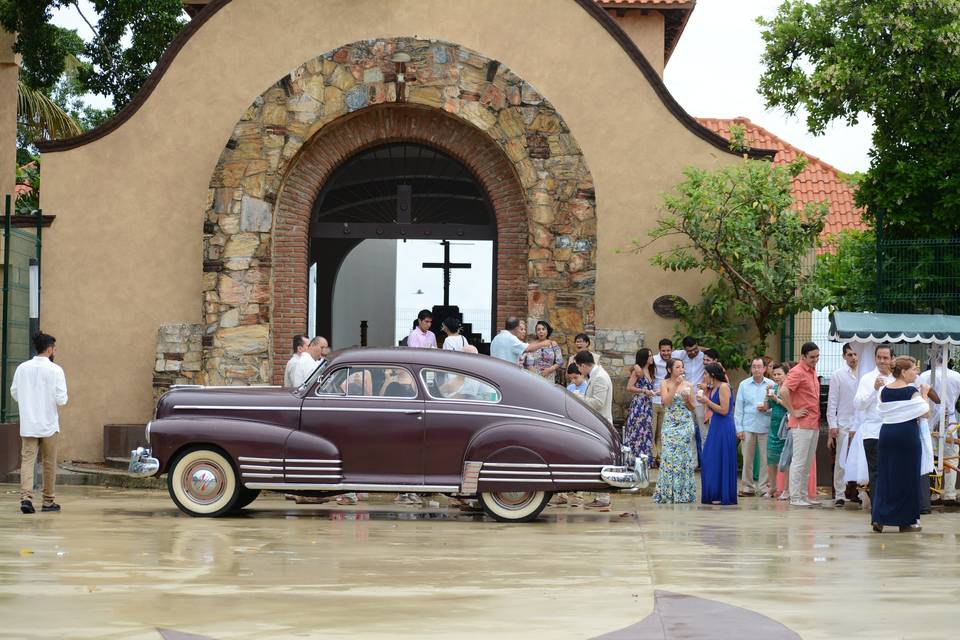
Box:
[0,0,185,109]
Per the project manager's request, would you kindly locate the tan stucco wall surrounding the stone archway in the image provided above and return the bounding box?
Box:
[42,0,732,459]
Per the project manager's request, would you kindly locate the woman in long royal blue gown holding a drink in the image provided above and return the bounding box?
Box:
[697,362,737,504]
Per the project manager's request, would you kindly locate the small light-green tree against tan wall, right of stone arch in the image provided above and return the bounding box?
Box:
[635,153,827,355]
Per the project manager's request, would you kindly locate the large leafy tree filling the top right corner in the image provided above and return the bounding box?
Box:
[759,0,960,237]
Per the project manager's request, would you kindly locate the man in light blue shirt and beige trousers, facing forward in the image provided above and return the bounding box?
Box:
[734,358,776,498]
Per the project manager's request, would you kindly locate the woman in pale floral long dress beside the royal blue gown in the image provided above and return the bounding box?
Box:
[653,358,697,504]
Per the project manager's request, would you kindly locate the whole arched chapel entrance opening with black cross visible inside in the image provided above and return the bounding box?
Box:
[308,141,497,348]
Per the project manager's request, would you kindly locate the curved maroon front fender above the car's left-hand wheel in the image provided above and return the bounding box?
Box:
[150,417,290,474]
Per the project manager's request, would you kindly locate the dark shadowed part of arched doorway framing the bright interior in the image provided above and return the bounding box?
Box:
[310,142,497,348]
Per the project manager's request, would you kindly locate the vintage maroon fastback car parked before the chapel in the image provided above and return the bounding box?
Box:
[130,348,646,522]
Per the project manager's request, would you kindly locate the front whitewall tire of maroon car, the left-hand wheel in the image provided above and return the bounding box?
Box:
[167,448,240,516]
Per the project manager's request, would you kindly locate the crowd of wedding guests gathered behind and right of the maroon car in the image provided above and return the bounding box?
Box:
[284,310,960,531]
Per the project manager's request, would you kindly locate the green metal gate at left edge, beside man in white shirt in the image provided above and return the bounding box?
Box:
[0,196,42,422]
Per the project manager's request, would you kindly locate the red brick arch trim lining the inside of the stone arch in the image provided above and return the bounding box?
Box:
[271,104,528,382]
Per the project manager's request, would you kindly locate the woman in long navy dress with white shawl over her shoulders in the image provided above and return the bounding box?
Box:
[871,356,932,533]
